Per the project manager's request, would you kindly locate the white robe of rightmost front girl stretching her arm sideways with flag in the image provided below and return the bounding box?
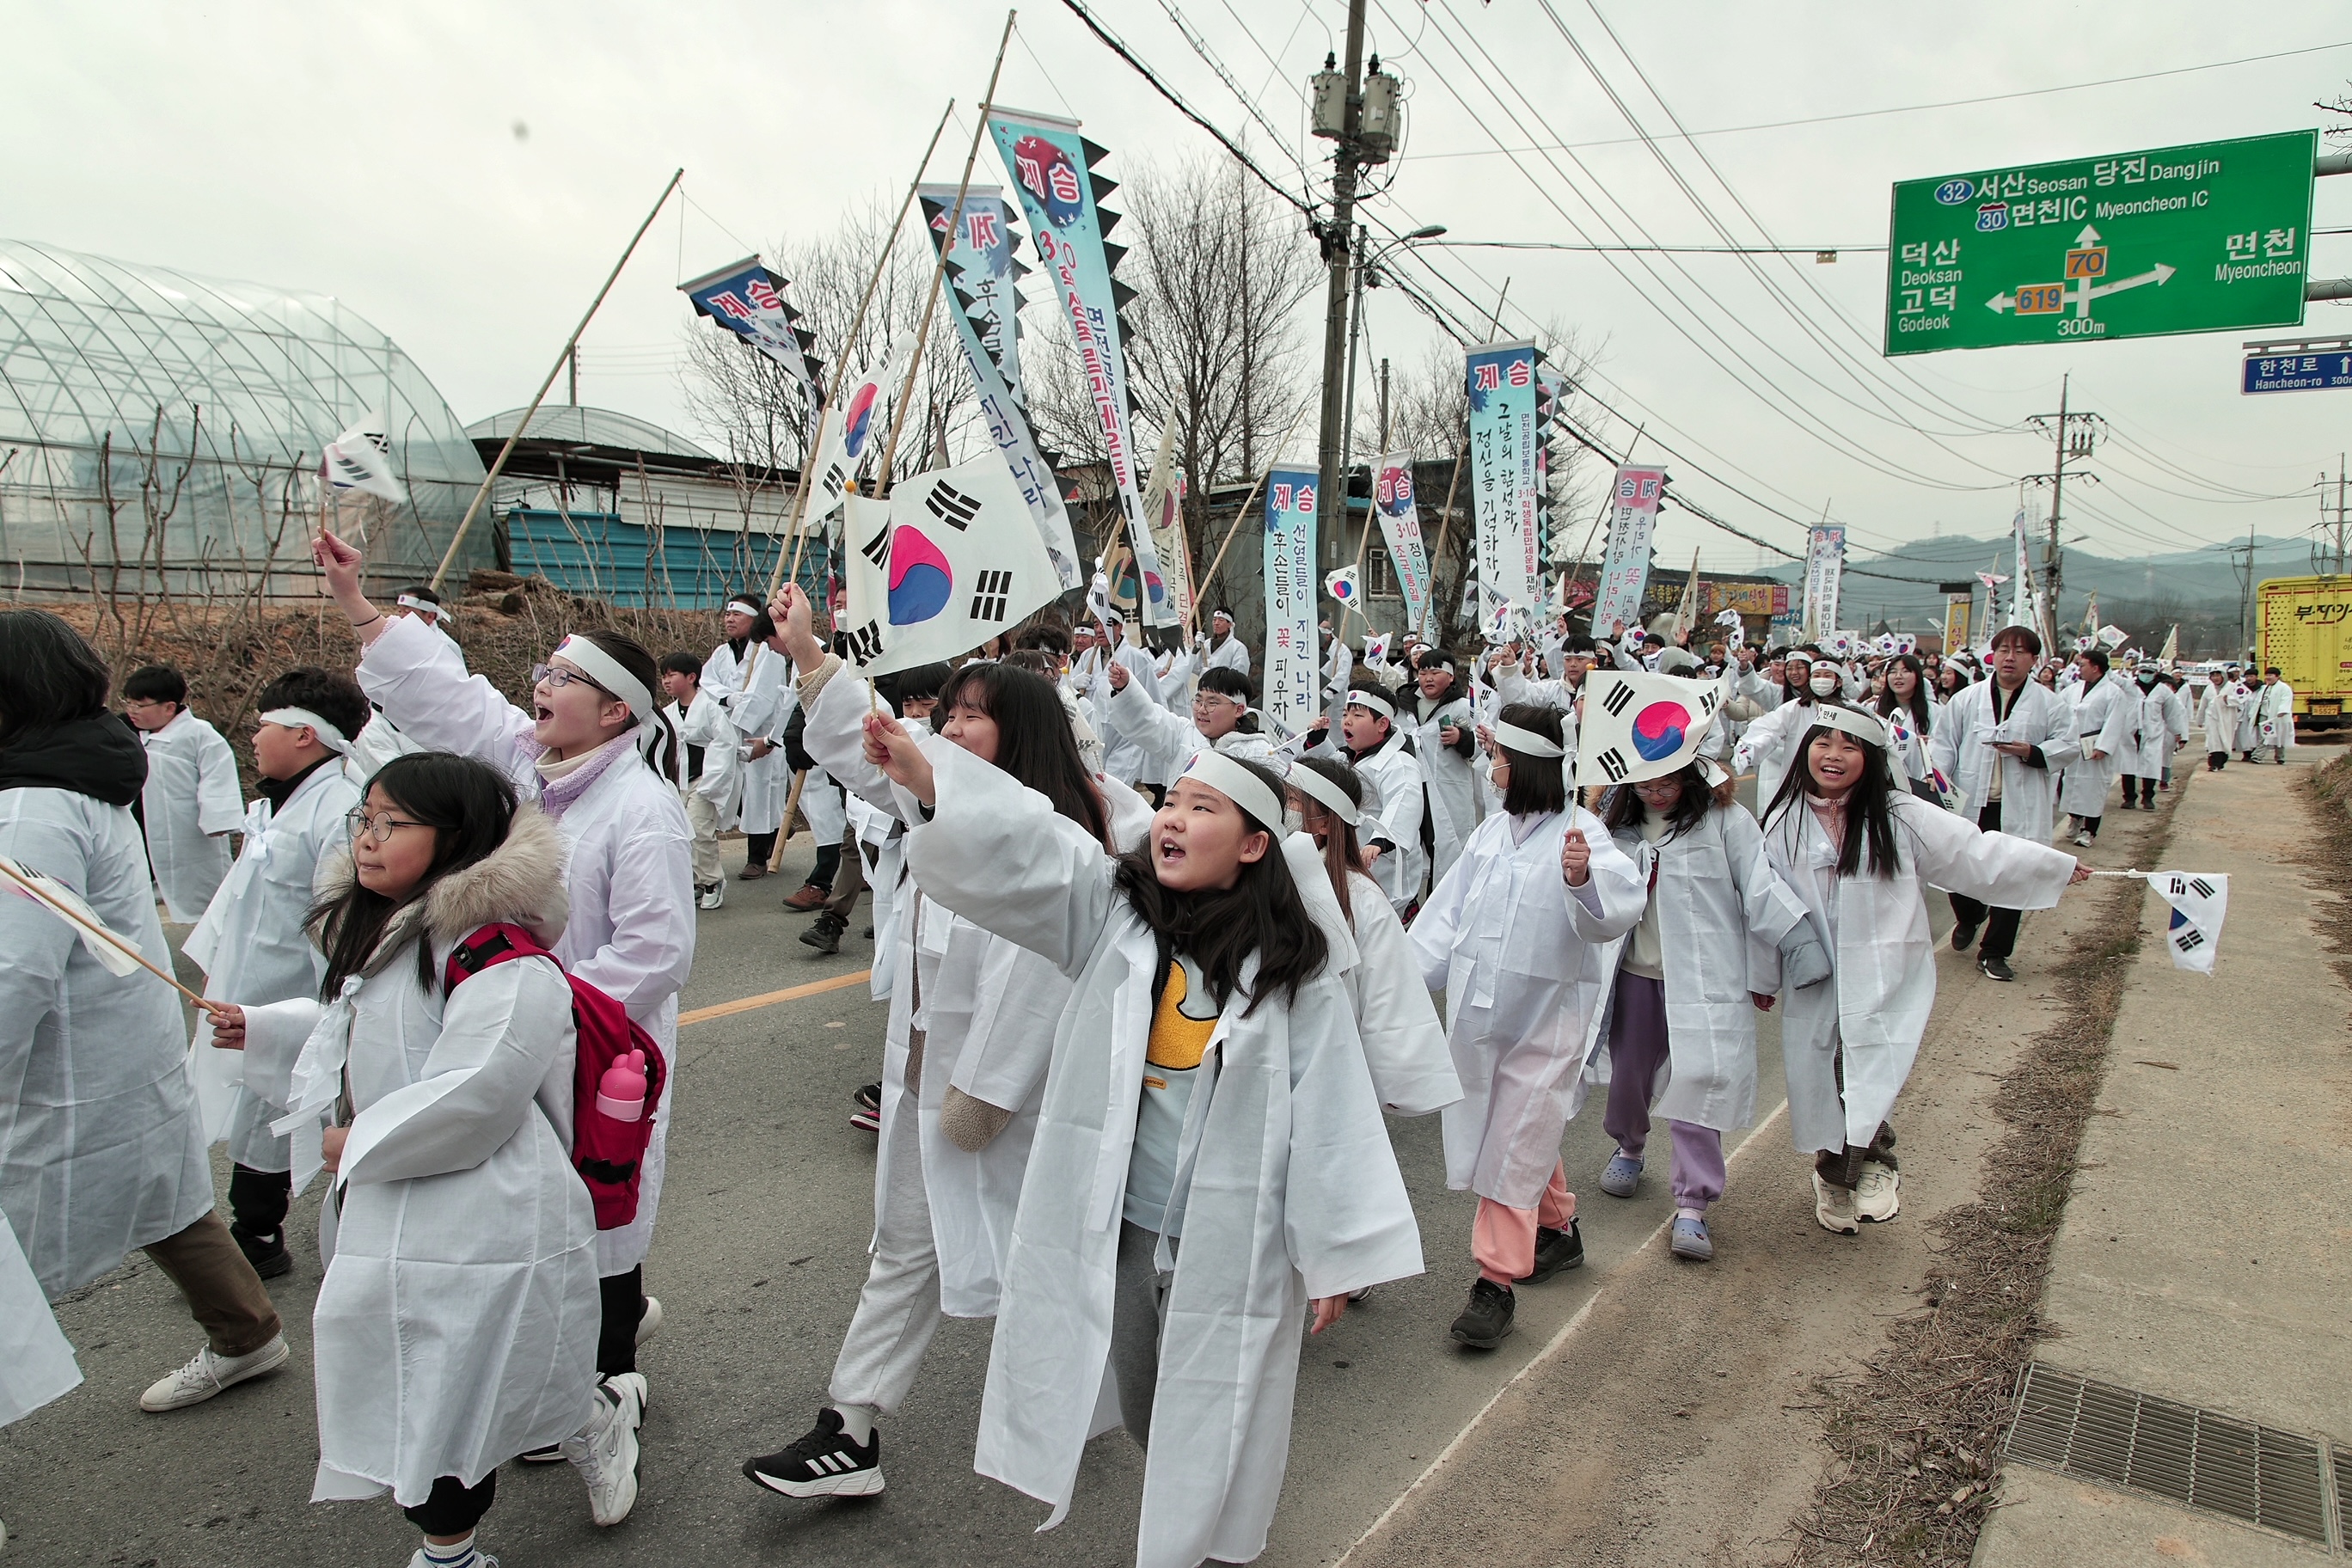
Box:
[1760,799,2074,1152]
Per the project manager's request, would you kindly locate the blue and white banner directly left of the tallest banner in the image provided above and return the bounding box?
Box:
[917,186,1084,588]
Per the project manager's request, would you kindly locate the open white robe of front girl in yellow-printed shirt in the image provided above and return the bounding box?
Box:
[908,740,1421,1568]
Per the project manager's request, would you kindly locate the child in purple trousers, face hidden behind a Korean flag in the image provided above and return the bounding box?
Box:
[1602,762,1828,1262]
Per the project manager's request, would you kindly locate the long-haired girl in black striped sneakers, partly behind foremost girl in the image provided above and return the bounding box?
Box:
[744,588,1141,1498]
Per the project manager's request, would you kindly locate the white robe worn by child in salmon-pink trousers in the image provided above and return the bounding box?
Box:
[1409,806,1646,1209]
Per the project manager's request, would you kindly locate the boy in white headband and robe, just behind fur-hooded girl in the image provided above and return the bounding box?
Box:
[186,665,370,1279]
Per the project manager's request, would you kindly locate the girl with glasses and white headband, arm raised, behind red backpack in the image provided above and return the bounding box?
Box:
[310,534,694,1400]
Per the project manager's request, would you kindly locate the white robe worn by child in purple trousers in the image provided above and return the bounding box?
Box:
[1592,804,1804,1133]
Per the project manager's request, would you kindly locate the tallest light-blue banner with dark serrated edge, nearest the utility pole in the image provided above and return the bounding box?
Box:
[988,111,1176,625]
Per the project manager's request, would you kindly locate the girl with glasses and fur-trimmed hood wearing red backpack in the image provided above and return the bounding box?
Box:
[228,762,642,1565]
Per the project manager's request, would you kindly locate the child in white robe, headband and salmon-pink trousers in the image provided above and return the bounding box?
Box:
[1412,703,1646,1350]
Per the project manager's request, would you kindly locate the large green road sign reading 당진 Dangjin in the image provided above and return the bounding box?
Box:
[1886,132,2317,355]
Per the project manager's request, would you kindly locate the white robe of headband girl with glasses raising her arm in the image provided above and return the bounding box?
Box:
[358,621,691,1274]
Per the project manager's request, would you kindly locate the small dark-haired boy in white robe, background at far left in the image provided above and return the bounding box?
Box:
[122,665,245,926]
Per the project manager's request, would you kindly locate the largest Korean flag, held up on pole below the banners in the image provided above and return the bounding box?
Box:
[842,454,1061,675]
